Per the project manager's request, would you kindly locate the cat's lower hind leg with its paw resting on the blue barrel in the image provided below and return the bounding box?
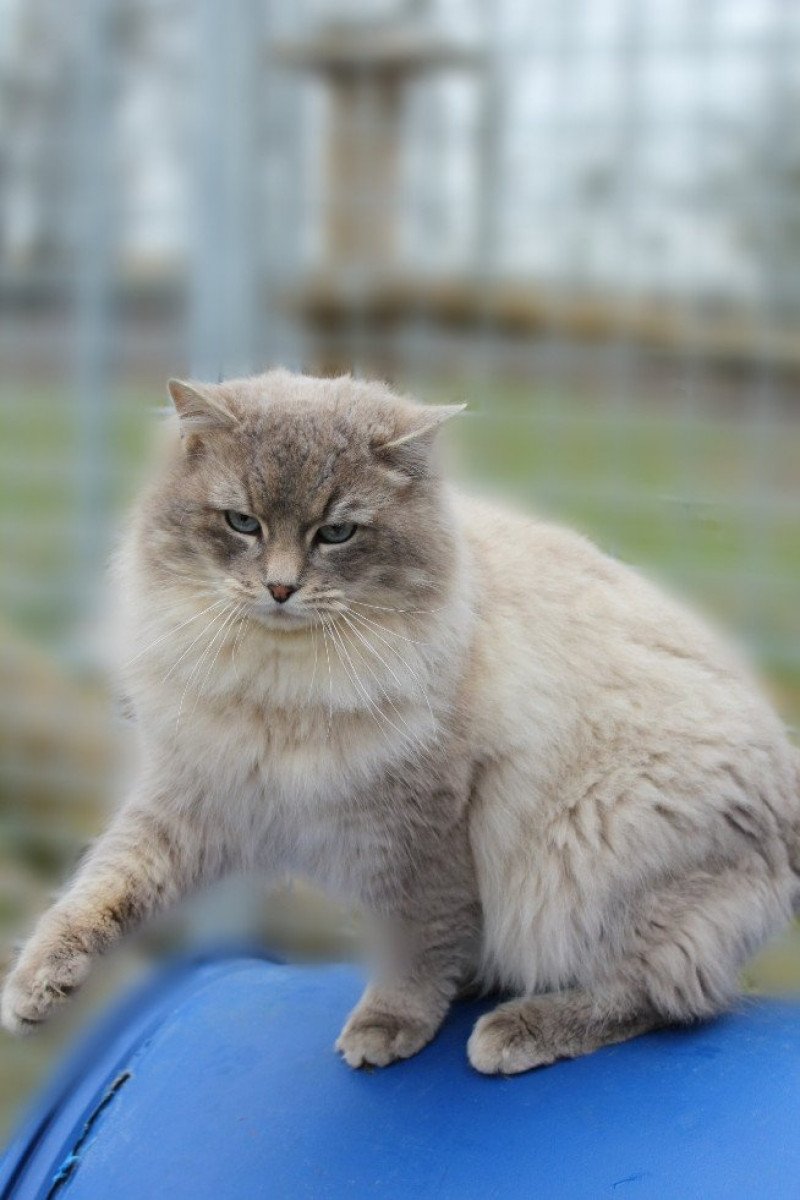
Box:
[468,857,788,1074]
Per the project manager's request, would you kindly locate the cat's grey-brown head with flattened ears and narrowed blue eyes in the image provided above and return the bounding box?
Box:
[144,372,455,632]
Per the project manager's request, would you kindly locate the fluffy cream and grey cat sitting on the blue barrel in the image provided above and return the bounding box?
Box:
[2,371,800,1074]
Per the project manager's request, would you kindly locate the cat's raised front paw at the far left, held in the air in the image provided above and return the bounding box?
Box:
[0,942,90,1033]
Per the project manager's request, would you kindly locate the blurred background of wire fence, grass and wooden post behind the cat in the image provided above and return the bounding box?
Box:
[0,0,800,1134]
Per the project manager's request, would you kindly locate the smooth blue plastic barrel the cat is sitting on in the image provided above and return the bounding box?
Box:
[0,956,800,1200]
